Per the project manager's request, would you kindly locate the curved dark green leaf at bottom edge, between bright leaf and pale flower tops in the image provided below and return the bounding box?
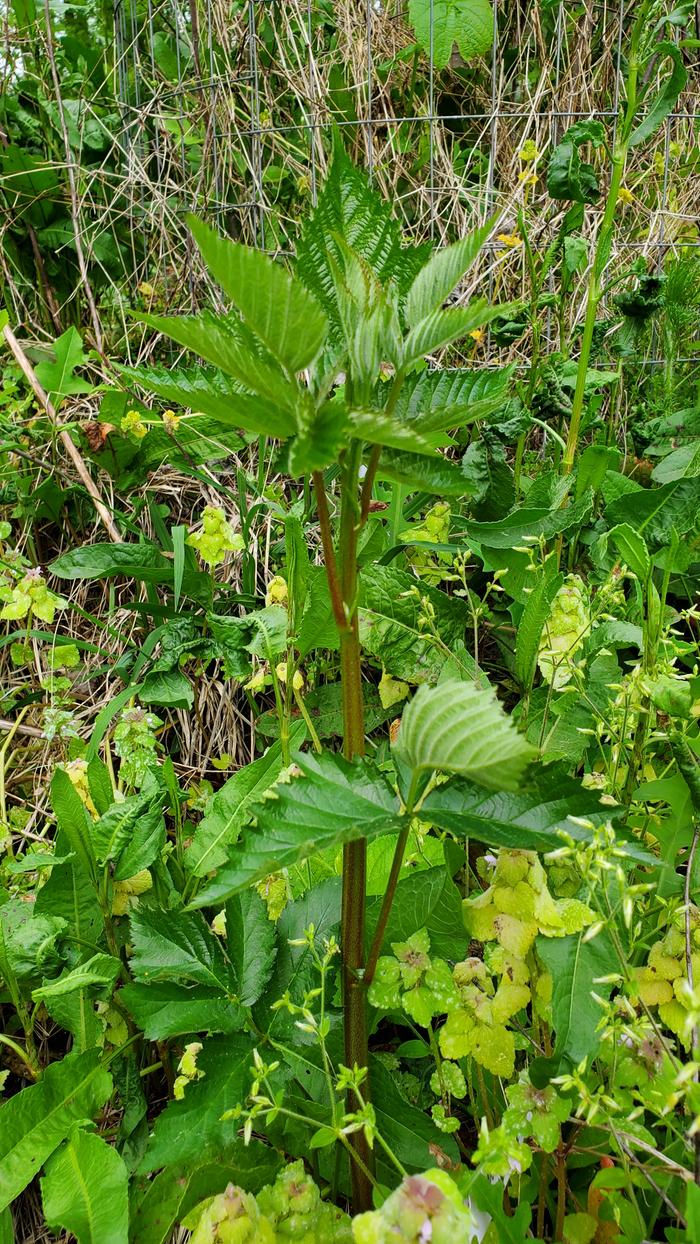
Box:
[129,1140,282,1244]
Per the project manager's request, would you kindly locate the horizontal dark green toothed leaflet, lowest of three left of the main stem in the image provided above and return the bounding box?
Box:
[118,980,245,1041]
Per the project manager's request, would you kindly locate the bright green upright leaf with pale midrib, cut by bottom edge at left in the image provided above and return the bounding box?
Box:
[41,1128,129,1244]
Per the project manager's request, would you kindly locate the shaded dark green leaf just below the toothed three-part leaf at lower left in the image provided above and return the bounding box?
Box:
[138,1034,254,1174]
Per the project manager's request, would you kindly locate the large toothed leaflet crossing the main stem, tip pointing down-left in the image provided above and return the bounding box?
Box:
[193,755,403,907]
